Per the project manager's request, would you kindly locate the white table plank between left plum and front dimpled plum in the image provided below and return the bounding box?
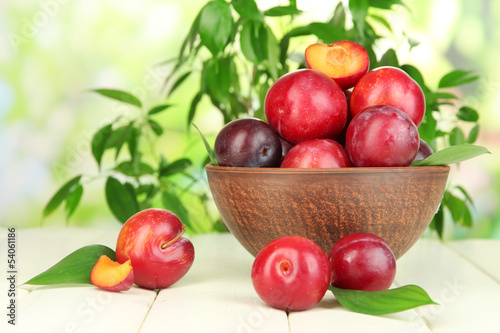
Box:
[141,234,288,333]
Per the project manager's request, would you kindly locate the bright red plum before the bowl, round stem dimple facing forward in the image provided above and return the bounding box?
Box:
[251,236,330,311]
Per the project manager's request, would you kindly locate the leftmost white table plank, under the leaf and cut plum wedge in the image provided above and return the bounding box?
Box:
[0,224,157,333]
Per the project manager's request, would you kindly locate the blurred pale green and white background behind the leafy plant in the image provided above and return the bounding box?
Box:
[0,0,500,239]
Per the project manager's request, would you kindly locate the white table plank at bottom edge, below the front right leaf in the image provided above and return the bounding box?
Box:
[289,284,431,333]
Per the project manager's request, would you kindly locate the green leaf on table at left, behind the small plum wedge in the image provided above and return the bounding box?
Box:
[24,245,116,285]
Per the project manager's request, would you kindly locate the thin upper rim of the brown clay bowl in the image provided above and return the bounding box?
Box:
[205,164,450,174]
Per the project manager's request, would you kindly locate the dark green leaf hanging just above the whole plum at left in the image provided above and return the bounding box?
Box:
[105,177,139,223]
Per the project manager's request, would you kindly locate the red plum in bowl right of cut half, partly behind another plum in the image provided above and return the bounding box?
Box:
[350,66,425,127]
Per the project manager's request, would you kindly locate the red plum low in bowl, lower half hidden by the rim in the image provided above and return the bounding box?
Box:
[281,139,352,168]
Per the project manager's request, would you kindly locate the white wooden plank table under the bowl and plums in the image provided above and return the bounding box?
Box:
[0,226,500,333]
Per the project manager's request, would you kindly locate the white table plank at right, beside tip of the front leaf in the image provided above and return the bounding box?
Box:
[397,239,500,333]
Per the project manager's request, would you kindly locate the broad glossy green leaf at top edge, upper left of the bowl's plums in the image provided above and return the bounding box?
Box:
[198,1,233,56]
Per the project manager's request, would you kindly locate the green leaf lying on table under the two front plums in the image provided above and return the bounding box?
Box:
[328,285,437,315]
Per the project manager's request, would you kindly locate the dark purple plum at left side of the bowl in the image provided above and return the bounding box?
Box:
[214,117,282,167]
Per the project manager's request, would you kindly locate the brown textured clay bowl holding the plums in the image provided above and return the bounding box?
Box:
[205,165,450,258]
